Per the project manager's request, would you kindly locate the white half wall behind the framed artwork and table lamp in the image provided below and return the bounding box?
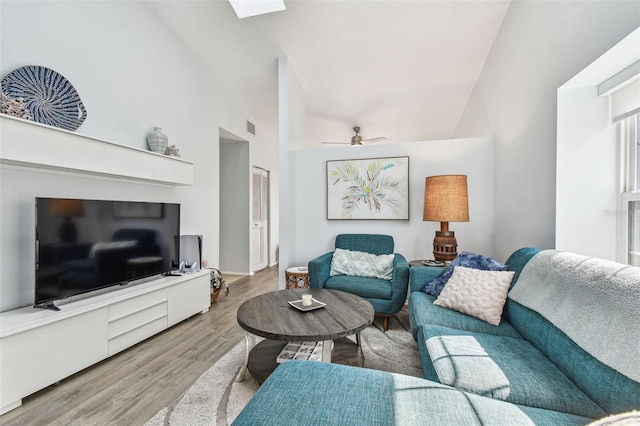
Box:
[288,138,496,267]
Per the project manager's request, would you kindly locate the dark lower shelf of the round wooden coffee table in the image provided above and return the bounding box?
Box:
[247,337,364,383]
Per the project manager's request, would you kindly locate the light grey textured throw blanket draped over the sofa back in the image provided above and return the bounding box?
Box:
[509,250,640,382]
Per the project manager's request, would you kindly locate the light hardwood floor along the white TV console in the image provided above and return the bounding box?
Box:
[0,266,278,426]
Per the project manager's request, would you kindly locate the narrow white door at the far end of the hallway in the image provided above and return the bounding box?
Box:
[251,166,270,272]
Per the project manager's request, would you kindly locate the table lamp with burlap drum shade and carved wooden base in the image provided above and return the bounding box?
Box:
[422,175,469,261]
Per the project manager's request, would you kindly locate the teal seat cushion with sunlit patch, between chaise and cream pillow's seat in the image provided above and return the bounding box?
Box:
[423,325,606,418]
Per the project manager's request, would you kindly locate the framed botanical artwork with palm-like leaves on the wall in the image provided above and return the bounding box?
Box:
[327,157,409,220]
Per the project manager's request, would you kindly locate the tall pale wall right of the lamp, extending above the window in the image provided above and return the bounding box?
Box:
[456,0,640,258]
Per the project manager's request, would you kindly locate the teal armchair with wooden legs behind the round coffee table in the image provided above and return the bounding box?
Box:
[309,234,409,331]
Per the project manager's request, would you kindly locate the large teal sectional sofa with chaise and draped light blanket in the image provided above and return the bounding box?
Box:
[234,248,640,425]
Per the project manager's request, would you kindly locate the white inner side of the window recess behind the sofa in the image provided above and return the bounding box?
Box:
[556,29,640,263]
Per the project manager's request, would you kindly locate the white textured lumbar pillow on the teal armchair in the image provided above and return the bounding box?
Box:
[330,248,394,280]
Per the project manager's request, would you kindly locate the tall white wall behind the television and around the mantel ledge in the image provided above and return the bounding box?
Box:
[0,1,277,310]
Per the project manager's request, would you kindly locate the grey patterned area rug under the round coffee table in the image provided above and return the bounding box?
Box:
[146,310,422,426]
